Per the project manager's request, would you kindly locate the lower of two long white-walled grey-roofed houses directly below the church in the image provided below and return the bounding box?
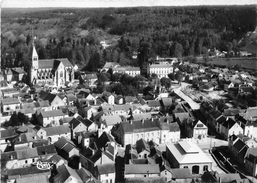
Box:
[37,124,71,144]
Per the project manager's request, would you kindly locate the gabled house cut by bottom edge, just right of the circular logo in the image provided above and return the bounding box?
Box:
[53,164,83,183]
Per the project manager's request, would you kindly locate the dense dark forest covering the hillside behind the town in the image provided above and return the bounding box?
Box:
[1,6,257,71]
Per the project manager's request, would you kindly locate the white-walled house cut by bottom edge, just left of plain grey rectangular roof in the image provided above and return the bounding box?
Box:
[96,163,115,183]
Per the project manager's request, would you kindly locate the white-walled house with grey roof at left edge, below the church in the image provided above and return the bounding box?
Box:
[1,97,21,116]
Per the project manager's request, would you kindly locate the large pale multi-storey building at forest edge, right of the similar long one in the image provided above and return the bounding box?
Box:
[149,63,173,78]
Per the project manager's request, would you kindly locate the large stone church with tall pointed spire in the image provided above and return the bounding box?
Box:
[30,44,74,87]
